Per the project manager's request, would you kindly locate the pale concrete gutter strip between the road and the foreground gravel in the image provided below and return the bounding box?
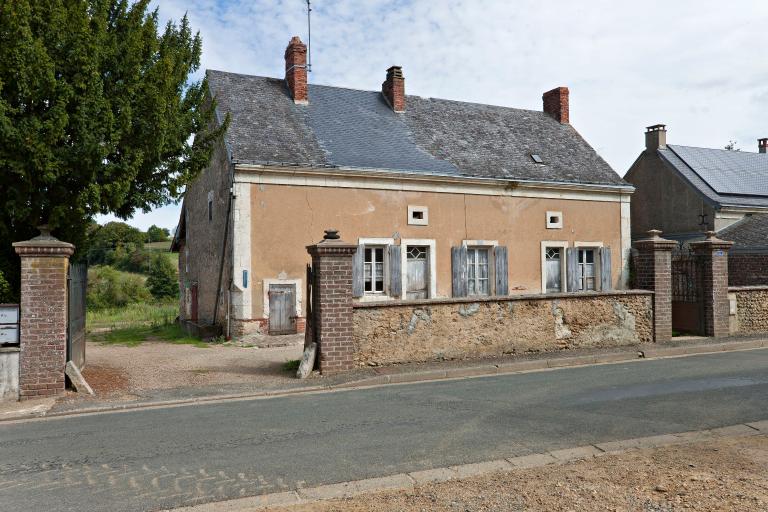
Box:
[173,420,768,512]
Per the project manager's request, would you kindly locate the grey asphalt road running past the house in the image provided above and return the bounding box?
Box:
[0,350,768,512]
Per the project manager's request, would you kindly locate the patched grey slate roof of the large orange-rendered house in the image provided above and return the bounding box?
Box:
[207,70,630,186]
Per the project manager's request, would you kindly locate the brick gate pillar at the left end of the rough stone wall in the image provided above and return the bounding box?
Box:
[307,230,357,373]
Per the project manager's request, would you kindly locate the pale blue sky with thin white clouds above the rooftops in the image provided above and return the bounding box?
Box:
[98,0,768,229]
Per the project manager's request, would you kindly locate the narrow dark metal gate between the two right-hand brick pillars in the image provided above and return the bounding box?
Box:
[672,247,704,335]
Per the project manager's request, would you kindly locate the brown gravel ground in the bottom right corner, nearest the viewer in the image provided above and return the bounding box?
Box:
[270,435,768,512]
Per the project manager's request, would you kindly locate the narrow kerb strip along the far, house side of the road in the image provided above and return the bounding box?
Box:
[0,339,768,423]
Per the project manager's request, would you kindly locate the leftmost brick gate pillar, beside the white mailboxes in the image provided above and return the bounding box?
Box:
[13,227,75,400]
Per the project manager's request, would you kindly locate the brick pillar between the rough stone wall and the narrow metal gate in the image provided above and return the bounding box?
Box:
[635,229,677,343]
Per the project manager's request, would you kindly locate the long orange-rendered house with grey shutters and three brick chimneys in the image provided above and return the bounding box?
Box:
[173,37,633,336]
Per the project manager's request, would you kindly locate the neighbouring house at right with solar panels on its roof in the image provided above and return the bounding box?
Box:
[624,124,768,285]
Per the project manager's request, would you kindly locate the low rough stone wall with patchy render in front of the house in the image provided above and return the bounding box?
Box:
[354,291,653,366]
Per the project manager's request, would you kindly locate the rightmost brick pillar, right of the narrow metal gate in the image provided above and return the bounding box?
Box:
[690,231,733,337]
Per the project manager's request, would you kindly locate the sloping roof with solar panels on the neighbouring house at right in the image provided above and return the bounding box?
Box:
[658,144,768,208]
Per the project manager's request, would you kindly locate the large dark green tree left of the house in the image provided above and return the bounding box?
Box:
[0,0,223,294]
